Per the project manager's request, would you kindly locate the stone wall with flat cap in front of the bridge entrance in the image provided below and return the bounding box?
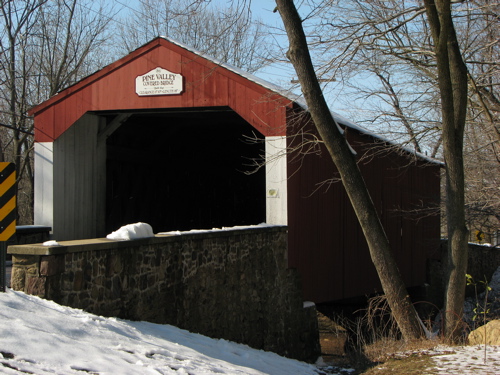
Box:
[8,226,320,361]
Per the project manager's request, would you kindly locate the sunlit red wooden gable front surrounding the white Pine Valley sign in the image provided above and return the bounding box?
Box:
[31,38,290,142]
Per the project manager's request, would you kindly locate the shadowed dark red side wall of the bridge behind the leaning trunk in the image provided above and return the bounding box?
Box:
[288,114,439,302]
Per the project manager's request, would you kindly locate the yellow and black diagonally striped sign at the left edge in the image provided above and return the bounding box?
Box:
[0,163,17,241]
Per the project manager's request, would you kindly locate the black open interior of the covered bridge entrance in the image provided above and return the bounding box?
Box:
[106,109,266,233]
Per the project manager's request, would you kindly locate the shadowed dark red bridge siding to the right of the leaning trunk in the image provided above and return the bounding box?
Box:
[357,134,440,300]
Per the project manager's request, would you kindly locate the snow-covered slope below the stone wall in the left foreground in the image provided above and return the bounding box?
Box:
[0,289,318,375]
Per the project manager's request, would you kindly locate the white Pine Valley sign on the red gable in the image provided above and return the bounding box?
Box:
[135,67,183,96]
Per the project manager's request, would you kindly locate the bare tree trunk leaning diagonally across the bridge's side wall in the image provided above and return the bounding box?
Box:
[276,0,423,339]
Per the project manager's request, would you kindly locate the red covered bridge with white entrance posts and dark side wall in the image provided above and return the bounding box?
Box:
[31,38,439,302]
